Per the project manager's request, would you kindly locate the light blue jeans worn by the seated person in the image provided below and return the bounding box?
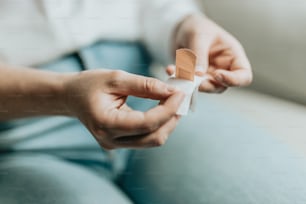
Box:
[0,42,306,204]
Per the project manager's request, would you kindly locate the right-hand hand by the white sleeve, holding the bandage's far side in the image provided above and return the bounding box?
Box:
[166,15,252,93]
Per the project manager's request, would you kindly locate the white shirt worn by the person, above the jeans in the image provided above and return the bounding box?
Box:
[0,0,199,66]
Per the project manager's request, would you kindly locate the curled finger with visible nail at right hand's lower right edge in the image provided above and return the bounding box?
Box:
[214,69,252,87]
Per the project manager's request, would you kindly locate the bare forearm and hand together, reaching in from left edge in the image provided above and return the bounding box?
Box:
[0,66,184,149]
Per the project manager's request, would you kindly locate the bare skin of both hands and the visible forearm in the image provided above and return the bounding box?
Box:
[0,15,252,149]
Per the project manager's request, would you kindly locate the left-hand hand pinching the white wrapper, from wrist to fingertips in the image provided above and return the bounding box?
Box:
[64,70,184,149]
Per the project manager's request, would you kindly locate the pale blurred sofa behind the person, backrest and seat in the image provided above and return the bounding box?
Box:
[189,0,306,153]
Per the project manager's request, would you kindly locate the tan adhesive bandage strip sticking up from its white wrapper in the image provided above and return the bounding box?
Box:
[175,48,197,81]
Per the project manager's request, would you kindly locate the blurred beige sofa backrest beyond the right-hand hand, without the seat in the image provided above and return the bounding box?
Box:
[197,0,306,104]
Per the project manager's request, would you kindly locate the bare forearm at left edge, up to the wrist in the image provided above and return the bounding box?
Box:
[0,65,71,121]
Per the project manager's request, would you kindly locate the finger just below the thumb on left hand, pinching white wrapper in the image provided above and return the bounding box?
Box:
[102,92,184,137]
